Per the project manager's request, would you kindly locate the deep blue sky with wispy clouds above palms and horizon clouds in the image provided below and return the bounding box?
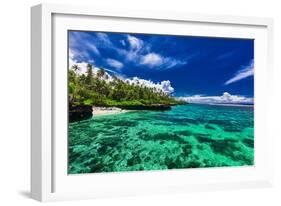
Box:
[68,31,254,100]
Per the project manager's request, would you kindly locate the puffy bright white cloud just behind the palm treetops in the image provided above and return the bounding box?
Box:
[125,77,174,94]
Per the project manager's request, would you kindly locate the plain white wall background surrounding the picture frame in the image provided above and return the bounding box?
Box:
[0,0,281,206]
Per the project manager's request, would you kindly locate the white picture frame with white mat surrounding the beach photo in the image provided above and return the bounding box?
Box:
[31,4,274,201]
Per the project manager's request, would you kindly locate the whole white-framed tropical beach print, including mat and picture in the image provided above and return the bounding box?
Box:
[31,4,273,201]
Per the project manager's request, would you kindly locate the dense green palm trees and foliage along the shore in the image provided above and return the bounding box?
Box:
[68,64,182,106]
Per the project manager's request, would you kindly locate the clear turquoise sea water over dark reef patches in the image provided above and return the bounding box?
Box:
[68,104,254,174]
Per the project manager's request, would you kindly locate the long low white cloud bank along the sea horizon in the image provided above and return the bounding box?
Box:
[179,92,254,104]
